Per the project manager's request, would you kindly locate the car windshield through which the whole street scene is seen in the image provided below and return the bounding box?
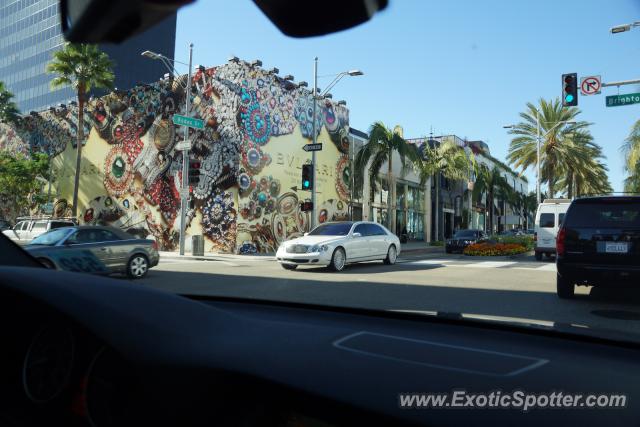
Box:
[0,0,640,348]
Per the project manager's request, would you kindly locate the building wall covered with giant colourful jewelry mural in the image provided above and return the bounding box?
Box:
[0,61,350,252]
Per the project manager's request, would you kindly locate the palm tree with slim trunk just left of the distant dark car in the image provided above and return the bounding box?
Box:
[414,141,469,240]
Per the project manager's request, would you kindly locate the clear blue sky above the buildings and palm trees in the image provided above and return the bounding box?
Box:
[176,0,640,191]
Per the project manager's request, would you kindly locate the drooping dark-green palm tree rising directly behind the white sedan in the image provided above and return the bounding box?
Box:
[354,121,416,231]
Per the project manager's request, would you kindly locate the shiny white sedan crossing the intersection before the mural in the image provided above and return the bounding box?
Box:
[276,221,400,271]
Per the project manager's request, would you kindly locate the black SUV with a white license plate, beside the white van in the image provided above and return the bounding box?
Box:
[556,196,640,298]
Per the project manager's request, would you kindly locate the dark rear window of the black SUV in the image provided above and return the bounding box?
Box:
[565,201,640,228]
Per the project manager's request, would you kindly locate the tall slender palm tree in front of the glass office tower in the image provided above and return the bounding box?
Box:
[46,43,114,216]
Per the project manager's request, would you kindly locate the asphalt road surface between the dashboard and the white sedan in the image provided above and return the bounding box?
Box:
[137,254,640,341]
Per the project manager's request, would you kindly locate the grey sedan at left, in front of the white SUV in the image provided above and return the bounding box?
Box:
[25,226,160,279]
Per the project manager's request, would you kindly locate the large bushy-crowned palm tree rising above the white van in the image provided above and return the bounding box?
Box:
[507,98,589,197]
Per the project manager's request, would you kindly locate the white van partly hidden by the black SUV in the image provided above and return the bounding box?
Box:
[534,199,571,261]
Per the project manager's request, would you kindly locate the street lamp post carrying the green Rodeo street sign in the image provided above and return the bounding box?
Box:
[141,43,193,255]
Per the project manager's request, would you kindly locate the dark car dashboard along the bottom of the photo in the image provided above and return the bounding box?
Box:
[0,267,640,427]
